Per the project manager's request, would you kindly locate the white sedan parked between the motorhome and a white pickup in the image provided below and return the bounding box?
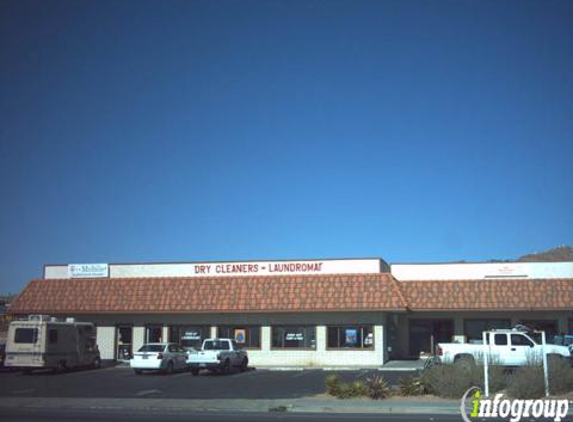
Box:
[129,343,187,375]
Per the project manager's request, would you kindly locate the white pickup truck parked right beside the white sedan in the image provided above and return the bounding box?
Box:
[187,338,249,375]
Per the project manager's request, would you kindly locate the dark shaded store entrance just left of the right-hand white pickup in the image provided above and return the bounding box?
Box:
[409,319,454,358]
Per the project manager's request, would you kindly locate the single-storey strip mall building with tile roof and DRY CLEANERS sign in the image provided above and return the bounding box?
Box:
[5,259,573,367]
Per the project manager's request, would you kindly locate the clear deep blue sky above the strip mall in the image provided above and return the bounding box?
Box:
[0,0,573,292]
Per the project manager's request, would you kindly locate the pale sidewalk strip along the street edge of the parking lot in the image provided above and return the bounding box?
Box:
[0,397,460,414]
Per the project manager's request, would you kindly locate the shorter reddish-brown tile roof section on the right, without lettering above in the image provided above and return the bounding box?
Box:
[399,278,573,311]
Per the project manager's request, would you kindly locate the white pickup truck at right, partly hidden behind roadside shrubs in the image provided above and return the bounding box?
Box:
[438,329,571,366]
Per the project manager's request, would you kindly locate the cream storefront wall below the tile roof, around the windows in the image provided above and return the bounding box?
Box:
[54,311,573,367]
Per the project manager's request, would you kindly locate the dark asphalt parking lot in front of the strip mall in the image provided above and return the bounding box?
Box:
[0,366,413,399]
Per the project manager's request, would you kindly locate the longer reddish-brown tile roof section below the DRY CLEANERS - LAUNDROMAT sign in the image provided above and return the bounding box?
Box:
[5,274,406,314]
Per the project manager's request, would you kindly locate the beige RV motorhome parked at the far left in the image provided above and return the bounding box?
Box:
[4,315,101,371]
